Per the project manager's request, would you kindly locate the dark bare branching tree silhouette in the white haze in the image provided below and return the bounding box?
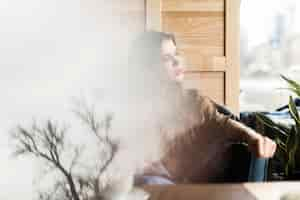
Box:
[12,101,118,200]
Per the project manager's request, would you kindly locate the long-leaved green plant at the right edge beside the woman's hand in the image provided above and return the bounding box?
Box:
[256,76,300,180]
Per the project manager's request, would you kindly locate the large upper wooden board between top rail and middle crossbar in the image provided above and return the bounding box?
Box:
[163,13,224,56]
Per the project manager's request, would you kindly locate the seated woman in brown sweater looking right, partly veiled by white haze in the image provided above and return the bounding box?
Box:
[129,32,276,183]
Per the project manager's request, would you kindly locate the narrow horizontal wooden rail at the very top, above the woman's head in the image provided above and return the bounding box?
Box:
[162,0,224,12]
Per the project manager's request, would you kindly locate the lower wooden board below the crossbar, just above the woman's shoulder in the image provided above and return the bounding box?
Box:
[183,72,225,104]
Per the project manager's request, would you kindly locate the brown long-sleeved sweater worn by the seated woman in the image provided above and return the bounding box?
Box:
[138,93,256,183]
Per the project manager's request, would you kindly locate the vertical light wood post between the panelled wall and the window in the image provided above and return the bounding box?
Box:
[225,0,240,114]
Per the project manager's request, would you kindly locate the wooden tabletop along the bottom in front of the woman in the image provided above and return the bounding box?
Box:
[144,182,300,200]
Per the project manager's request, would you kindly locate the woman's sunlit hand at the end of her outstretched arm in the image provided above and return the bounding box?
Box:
[248,133,276,158]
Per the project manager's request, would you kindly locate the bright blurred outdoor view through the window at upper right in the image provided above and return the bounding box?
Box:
[240,0,300,111]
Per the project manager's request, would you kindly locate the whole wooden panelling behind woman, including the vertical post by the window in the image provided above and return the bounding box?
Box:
[158,0,240,113]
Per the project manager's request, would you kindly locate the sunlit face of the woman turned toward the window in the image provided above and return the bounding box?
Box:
[161,39,184,82]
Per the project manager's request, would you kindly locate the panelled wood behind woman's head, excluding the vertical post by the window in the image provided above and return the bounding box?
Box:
[162,0,227,104]
